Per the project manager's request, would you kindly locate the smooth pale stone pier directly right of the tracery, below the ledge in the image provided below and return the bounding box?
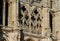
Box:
[42,8,51,41]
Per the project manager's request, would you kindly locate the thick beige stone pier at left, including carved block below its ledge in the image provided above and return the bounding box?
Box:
[4,0,19,41]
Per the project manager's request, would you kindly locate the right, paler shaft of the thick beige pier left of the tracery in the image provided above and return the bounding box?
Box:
[12,0,18,29]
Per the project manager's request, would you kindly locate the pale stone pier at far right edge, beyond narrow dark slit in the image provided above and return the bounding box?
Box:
[52,0,60,41]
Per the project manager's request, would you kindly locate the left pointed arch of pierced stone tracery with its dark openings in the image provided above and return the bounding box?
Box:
[19,5,29,25]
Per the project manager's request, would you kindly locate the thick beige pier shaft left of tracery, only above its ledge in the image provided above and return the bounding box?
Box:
[8,0,17,29]
